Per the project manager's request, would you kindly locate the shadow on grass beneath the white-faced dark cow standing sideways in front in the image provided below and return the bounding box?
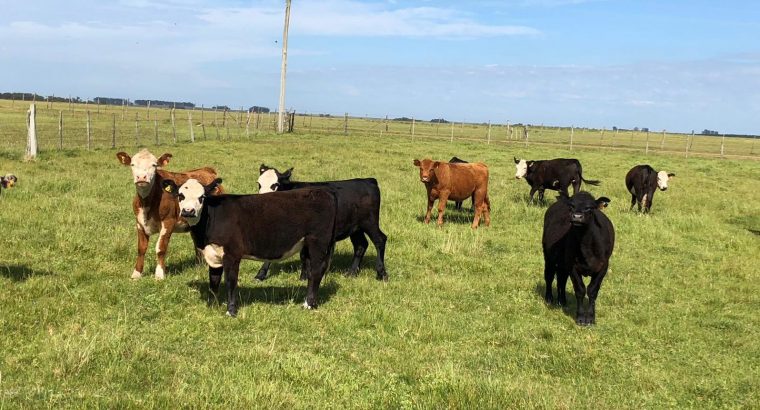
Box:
[187,280,340,307]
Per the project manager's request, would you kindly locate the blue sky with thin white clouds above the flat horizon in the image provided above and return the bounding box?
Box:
[0,0,760,134]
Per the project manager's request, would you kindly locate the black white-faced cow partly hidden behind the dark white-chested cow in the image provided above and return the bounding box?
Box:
[256,164,388,281]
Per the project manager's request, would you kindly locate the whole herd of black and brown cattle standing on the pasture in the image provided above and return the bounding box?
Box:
[0,149,675,325]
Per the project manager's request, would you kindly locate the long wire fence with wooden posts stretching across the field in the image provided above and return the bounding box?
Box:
[0,100,760,159]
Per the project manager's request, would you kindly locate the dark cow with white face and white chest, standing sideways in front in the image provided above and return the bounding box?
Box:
[163,179,337,317]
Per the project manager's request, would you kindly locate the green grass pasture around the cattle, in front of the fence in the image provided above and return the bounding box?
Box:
[0,128,760,409]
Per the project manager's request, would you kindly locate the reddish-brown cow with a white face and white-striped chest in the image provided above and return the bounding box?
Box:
[116,149,223,279]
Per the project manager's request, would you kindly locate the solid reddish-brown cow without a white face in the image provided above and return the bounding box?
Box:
[414,159,491,229]
